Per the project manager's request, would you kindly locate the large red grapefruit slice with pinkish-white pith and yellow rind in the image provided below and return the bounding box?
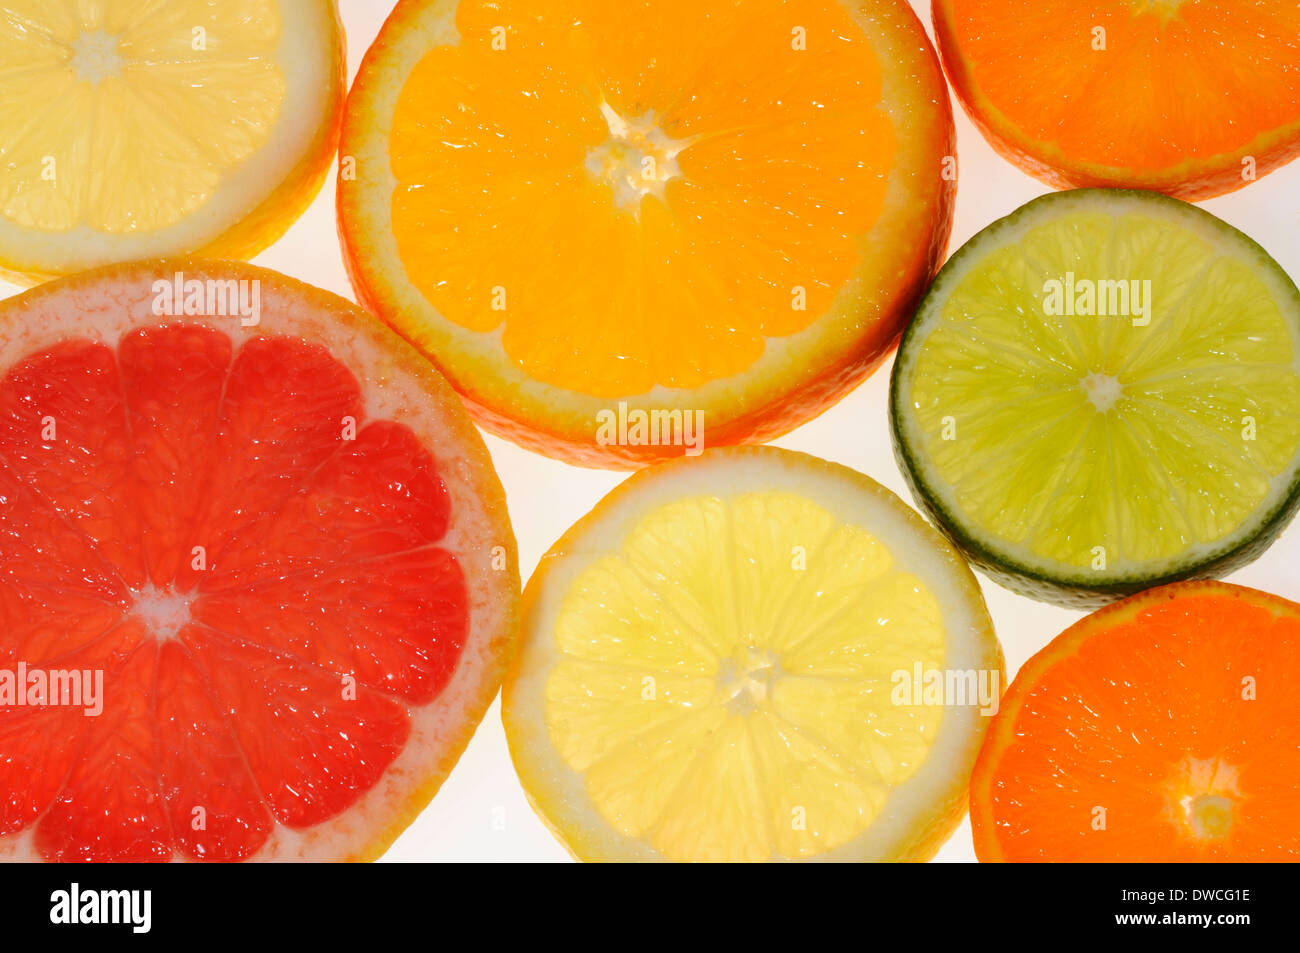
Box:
[0,260,519,861]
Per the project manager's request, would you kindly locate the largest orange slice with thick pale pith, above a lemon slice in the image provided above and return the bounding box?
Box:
[338,0,956,467]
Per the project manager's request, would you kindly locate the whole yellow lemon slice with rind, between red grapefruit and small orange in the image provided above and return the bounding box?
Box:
[503,447,1004,861]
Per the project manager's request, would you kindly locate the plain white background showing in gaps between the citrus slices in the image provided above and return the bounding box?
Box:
[0,0,1300,861]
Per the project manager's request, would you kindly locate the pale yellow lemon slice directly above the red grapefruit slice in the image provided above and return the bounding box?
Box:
[0,0,347,283]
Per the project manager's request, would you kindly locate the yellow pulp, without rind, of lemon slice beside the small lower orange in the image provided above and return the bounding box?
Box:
[546,490,945,861]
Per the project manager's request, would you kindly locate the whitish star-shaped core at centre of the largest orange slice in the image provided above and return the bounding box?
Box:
[584,103,689,216]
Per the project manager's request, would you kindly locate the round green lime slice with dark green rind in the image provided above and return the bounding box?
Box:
[891,189,1300,606]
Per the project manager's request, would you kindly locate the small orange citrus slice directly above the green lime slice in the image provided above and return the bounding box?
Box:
[933,0,1300,200]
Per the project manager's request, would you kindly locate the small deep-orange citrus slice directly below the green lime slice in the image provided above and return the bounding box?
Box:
[971,582,1300,862]
